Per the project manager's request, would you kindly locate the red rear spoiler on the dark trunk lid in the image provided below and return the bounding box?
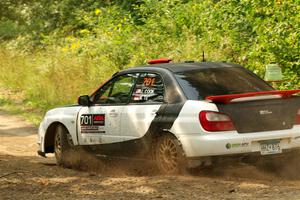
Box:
[205,89,300,104]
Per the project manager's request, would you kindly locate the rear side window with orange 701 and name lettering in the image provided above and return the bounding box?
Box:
[131,73,164,103]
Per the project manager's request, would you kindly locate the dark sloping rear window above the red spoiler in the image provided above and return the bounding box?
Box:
[175,67,273,100]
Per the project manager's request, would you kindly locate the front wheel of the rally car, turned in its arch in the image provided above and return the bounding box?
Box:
[54,125,75,167]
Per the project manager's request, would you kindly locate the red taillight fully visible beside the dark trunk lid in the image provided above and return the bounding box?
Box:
[199,111,235,132]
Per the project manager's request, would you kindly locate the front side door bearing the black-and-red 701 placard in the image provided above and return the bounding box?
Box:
[77,74,137,145]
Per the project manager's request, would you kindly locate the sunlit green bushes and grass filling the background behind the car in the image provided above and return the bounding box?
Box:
[0,0,300,117]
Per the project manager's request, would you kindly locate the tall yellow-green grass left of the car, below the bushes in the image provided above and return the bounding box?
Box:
[0,49,115,124]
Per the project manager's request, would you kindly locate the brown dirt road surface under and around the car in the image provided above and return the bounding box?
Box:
[0,111,300,200]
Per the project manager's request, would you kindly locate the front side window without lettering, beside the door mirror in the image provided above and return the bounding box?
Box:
[93,74,138,104]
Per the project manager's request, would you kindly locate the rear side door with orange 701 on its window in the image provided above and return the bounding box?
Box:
[121,73,165,140]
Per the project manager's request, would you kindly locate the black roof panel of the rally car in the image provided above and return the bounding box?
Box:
[118,61,242,73]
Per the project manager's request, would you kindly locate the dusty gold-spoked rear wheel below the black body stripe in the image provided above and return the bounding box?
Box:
[155,134,187,174]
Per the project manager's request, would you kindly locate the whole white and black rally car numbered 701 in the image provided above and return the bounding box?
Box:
[38,59,300,173]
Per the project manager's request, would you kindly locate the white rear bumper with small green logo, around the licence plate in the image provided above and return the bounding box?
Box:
[179,126,300,158]
